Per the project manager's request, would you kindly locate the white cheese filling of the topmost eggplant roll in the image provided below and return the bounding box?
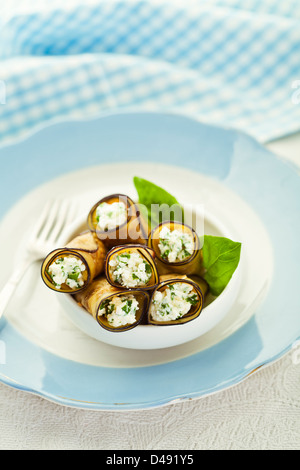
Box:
[96,202,127,232]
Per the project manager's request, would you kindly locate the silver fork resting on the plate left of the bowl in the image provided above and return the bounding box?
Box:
[0,199,76,318]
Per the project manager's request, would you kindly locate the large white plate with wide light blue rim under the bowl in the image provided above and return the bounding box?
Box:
[0,111,300,410]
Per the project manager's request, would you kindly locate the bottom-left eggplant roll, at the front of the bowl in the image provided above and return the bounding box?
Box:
[74,276,150,332]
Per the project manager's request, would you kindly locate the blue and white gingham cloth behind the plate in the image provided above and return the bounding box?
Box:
[0,0,300,147]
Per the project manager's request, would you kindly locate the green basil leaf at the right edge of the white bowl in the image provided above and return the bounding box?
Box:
[202,235,242,296]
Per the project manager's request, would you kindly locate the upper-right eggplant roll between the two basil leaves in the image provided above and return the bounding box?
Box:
[148,221,202,275]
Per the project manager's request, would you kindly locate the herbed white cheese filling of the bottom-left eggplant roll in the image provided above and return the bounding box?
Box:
[98,295,139,327]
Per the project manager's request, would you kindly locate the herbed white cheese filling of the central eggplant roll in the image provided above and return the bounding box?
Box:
[109,252,152,287]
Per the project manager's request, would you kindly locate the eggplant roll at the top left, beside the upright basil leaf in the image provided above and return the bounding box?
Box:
[88,194,148,248]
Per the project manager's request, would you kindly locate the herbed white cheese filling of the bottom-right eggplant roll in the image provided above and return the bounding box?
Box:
[150,282,198,322]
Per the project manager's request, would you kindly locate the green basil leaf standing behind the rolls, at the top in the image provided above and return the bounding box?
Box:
[133,176,183,228]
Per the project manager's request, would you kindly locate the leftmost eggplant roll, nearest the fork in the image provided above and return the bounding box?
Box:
[41,231,107,293]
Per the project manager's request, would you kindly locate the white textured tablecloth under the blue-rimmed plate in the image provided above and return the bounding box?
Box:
[0,130,300,450]
